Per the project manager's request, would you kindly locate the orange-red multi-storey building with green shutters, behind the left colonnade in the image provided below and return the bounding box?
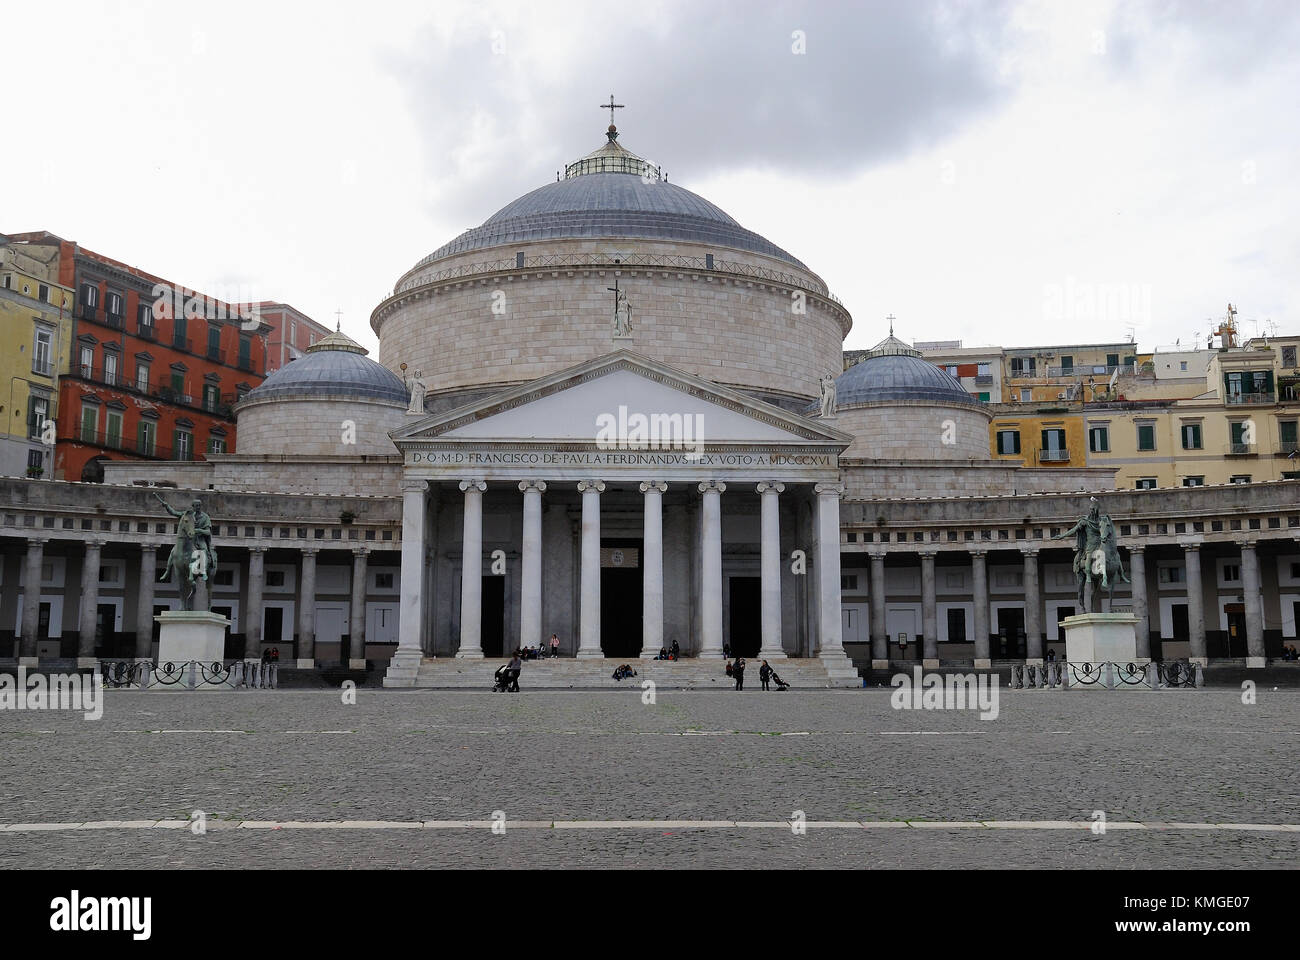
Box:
[6,233,279,483]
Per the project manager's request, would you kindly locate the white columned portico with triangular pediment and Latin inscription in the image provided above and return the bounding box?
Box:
[389,351,849,684]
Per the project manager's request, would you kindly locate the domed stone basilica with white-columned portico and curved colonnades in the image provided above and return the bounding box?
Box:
[0,124,1300,687]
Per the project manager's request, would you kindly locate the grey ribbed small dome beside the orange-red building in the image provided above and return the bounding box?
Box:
[244,330,411,407]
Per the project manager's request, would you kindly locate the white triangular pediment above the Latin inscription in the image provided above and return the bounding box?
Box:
[393,350,852,449]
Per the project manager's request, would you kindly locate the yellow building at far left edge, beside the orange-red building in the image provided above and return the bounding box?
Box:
[0,234,73,477]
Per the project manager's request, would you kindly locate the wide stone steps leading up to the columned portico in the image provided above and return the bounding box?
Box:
[384,657,862,691]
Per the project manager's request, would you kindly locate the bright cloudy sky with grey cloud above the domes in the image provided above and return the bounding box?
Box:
[0,0,1300,350]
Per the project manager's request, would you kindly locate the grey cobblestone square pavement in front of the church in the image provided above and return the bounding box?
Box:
[0,689,1300,868]
